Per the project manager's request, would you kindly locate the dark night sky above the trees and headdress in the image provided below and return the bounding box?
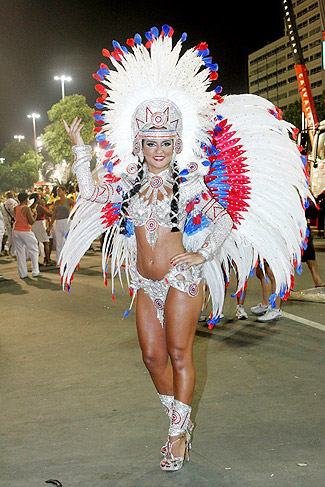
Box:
[0,0,284,151]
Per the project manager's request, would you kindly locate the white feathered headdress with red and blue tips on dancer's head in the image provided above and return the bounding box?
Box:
[94,25,221,176]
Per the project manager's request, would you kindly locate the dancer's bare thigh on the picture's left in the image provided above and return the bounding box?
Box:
[136,289,168,360]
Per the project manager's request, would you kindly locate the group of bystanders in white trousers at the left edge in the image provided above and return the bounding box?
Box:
[0,185,78,279]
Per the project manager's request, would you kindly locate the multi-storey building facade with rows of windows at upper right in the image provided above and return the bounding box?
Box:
[248,0,325,110]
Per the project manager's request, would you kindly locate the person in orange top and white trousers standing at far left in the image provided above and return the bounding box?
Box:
[12,193,40,279]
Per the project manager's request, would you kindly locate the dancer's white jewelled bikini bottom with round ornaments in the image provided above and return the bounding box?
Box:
[130,264,203,327]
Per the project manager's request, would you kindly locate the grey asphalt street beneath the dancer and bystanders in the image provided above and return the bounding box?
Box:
[0,239,325,487]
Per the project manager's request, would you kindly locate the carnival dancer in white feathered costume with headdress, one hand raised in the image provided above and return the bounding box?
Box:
[60,25,309,471]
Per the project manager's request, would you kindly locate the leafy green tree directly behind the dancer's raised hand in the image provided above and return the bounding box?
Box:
[41,95,94,164]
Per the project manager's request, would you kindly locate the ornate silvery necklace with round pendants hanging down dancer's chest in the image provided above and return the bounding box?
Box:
[141,168,174,250]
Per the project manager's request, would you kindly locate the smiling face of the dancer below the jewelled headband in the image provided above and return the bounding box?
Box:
[142,139,174,174]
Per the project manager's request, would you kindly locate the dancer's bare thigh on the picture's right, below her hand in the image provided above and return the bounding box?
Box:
[165,281,203,353]
